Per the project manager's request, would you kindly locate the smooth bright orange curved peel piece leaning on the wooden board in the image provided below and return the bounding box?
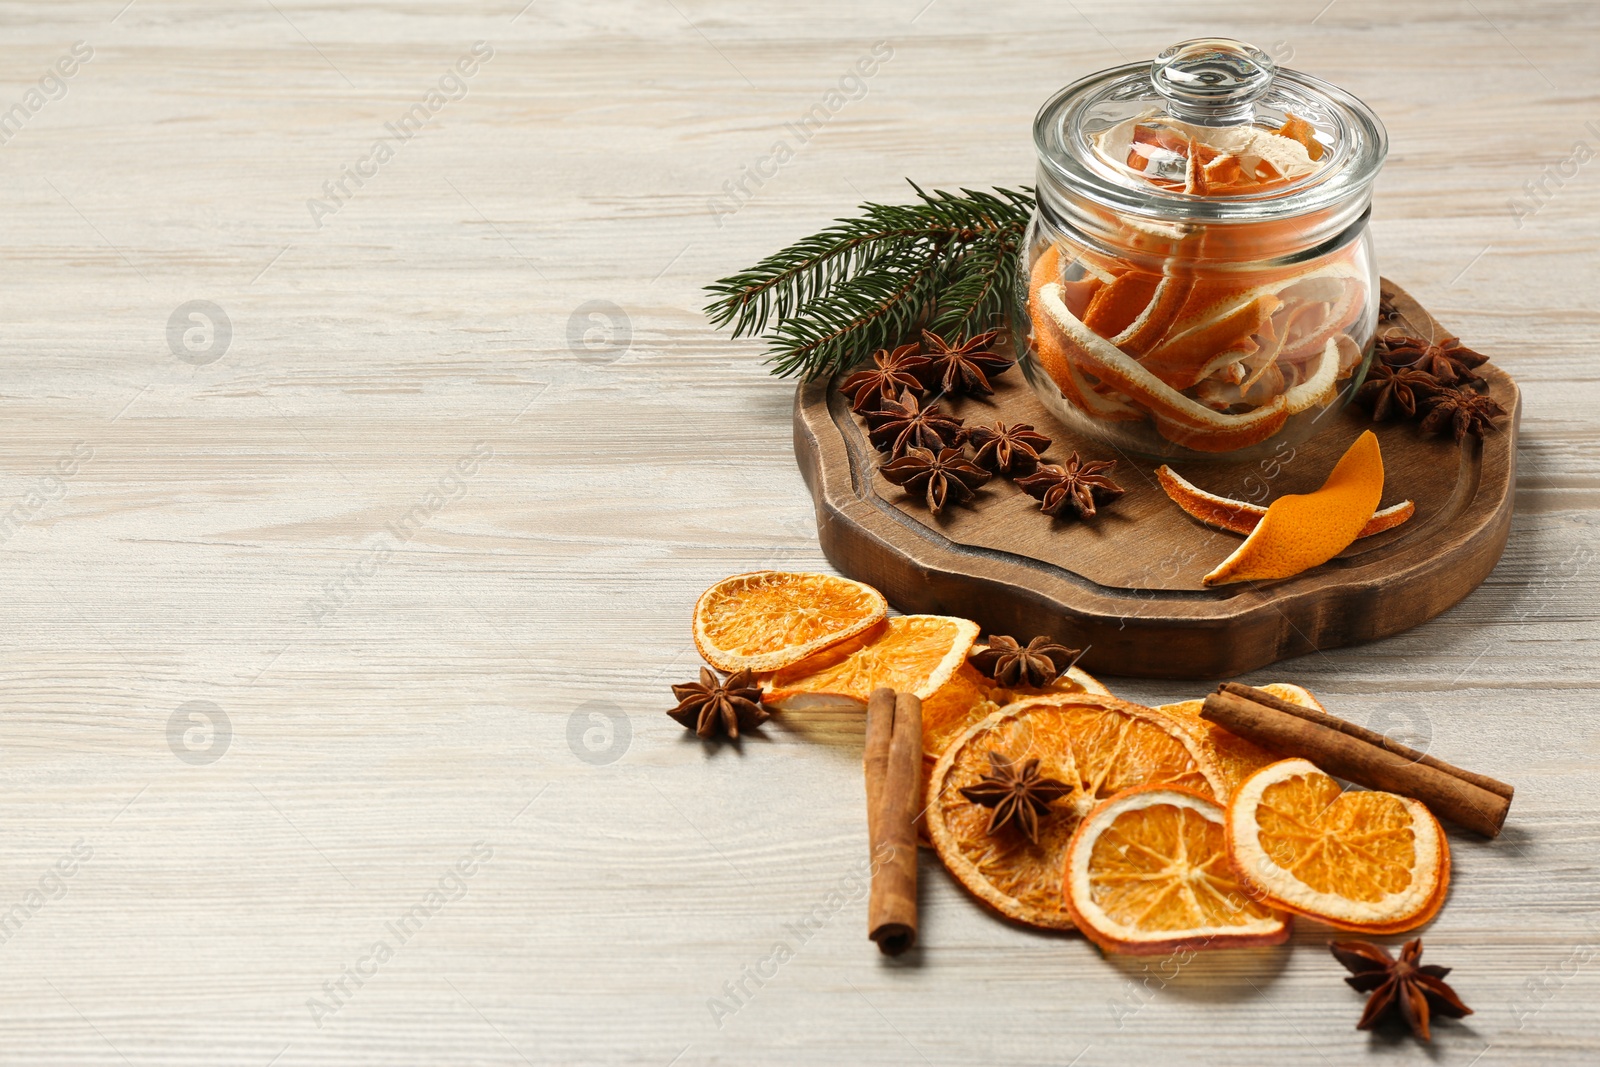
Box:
[1200,430,1384,585]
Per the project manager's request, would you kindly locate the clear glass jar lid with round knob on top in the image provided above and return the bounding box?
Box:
[1034,37,1387,221]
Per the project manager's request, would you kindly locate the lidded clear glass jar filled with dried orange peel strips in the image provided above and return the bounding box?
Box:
[1016,38,1387,459]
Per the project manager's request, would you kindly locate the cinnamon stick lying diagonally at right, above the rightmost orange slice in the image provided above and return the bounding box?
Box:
[1200,681,1515,837]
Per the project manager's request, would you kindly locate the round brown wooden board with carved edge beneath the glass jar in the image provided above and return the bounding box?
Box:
[795,280,1522,678]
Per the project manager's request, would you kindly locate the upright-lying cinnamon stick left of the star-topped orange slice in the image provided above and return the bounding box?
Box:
[864,689,922,955]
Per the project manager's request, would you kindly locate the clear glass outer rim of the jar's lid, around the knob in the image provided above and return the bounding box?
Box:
[1034,62,1389,222]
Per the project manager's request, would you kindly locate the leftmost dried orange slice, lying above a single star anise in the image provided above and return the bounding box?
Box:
[694,571,890,672]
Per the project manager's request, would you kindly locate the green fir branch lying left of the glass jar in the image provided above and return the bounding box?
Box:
[706,182,1034,378]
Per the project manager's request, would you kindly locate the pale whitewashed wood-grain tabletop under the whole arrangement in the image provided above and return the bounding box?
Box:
[0,0,1600,1067]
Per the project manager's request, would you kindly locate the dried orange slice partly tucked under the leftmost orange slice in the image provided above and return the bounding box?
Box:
[762,614,978,710]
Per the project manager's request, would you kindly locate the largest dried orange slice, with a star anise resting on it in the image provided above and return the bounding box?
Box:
[925,693,1222,929]
